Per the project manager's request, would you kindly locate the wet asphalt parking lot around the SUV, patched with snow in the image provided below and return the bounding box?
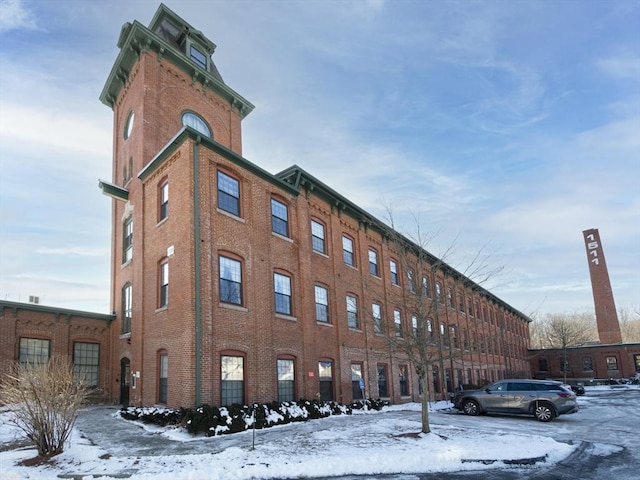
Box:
[380,388,640,480]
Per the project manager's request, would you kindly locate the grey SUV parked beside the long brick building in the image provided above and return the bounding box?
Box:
[453,379,578,422]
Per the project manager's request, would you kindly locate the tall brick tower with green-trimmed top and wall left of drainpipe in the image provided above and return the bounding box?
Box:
[100,4,253,404]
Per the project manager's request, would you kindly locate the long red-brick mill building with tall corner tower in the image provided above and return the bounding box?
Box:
[0,5,530,407]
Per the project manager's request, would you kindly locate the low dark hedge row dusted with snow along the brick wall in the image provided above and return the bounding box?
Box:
[120,399,389,437]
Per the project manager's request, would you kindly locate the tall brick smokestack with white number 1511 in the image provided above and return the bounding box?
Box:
[582,228,622,344]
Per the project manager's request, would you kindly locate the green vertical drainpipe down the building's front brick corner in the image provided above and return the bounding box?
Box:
[193,135,202,407]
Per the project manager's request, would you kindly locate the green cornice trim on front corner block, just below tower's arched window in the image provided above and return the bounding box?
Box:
[138,126,300,196]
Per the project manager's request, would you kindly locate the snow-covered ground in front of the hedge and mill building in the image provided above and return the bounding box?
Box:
[0,387,632,480]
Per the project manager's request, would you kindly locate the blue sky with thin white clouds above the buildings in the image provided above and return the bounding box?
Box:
[0,0,640,314]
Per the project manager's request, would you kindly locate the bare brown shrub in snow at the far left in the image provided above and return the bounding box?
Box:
[0,356,87,459]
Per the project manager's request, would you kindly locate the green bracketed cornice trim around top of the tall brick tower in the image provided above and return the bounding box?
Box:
[100,11,255,118]
